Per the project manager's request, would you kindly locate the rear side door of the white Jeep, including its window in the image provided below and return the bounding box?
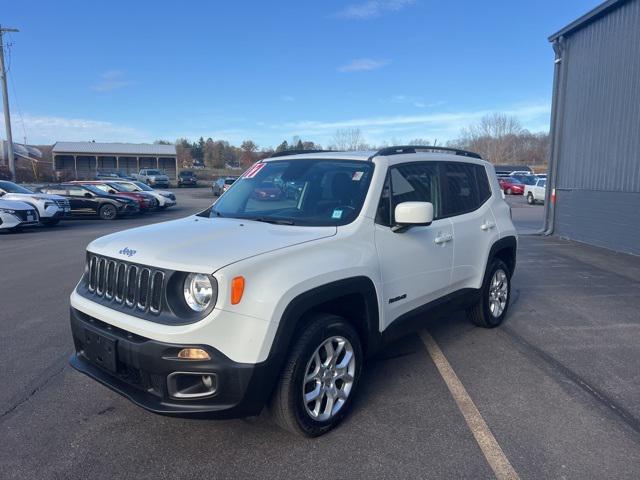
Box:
[443,162,499,291]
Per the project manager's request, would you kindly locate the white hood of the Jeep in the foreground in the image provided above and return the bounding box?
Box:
[87,215,337,273]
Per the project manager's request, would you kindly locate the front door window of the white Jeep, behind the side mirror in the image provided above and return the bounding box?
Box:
[376,162,442,226]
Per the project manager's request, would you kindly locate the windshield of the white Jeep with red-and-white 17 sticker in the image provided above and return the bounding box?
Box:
[210,159,373,226]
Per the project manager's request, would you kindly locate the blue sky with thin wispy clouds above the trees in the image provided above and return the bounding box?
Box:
[1,0,599,147]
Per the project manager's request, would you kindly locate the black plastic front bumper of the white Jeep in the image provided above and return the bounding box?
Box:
[70,308,274,418]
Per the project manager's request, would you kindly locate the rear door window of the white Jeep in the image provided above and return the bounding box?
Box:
[444,162,488,216]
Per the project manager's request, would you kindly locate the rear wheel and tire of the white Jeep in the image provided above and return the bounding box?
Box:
[467,258,511,328]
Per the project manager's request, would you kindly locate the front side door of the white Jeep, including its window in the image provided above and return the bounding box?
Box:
[375,162,453,329]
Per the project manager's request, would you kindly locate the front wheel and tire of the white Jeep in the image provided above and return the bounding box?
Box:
[269,314,363,437]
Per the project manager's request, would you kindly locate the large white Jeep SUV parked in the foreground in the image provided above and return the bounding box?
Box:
[71,146,517,436]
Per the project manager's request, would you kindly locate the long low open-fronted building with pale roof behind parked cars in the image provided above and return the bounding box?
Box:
[53,142,178,179]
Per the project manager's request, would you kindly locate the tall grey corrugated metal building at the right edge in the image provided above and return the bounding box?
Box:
[545,0,640,255]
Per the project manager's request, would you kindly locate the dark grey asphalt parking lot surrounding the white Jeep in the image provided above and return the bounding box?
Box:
[0,189,640,479]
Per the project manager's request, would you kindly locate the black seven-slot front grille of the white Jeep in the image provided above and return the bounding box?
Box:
[87,254,165,314]
